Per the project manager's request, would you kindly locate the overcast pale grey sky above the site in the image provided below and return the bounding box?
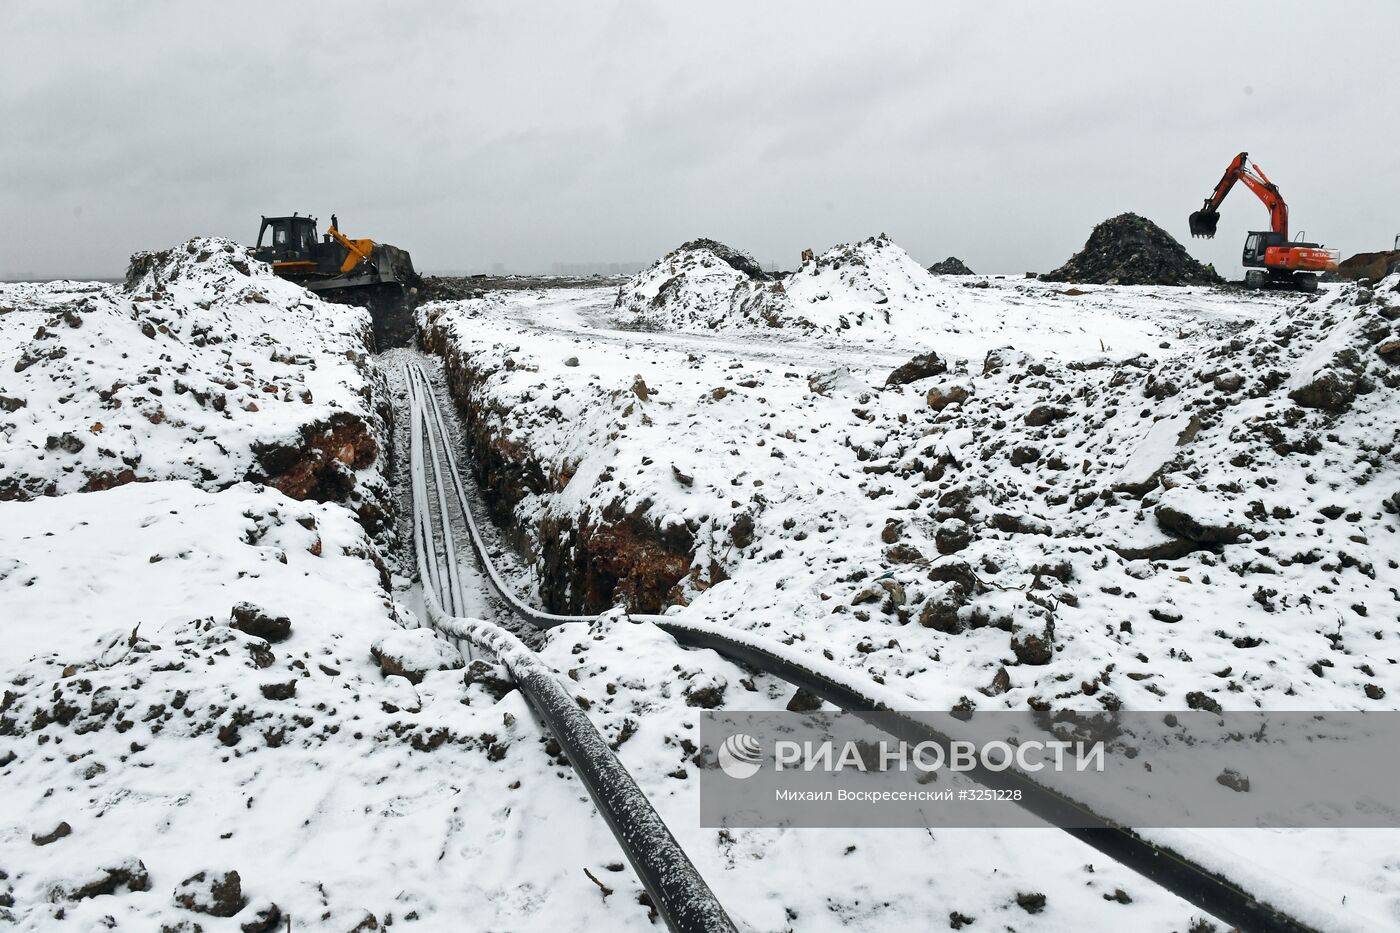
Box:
[0,0,1400,279]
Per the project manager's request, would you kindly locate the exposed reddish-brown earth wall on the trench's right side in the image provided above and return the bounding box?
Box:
[420,318,694,615]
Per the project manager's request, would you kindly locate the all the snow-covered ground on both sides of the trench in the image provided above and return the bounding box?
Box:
[0,228,1400,933]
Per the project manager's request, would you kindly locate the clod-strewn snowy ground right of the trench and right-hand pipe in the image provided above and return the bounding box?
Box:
[421,241,1400,929]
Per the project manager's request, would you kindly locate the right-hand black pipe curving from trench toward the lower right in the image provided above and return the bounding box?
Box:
[413,355,1319,933]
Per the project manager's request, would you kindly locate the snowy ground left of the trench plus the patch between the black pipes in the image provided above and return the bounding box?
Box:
[0,241,1215,932]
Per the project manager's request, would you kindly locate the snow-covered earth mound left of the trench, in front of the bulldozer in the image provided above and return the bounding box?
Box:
[0,238,386,527]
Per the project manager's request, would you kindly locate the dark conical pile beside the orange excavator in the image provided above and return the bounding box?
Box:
[1040,213,1221,286]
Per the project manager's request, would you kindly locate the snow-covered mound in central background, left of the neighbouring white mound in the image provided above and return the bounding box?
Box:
[616,240,788,329]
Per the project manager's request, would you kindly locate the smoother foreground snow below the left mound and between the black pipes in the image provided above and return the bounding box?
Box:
[0,482,1220,933]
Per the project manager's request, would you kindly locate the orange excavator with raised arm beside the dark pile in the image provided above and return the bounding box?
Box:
[1190,153,1341,291]
